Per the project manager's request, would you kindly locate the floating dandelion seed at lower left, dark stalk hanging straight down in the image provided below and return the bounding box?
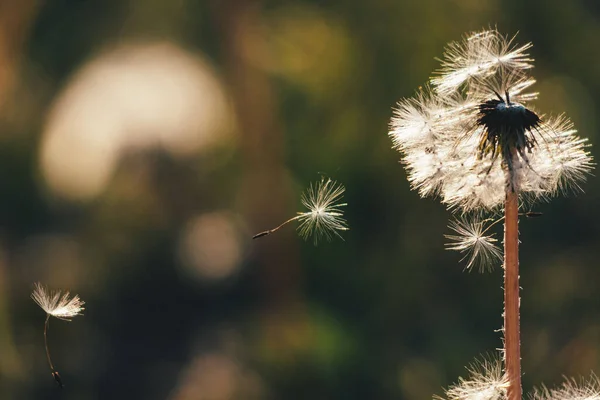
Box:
[31,282,85,389]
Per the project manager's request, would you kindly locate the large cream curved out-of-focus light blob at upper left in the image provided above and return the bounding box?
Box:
[41,43,233,199]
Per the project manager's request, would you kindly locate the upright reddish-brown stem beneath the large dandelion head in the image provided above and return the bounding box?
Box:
[504,188,522,400]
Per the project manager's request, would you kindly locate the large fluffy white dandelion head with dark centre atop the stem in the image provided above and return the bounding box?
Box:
[389,29,594,211]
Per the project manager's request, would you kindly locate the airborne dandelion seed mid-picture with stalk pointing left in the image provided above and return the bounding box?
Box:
[253,178,348,245]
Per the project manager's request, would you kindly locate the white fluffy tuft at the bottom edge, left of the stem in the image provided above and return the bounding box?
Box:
[438,358,508,400]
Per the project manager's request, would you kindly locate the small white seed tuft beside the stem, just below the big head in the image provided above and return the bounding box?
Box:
[444,216,502,271]
